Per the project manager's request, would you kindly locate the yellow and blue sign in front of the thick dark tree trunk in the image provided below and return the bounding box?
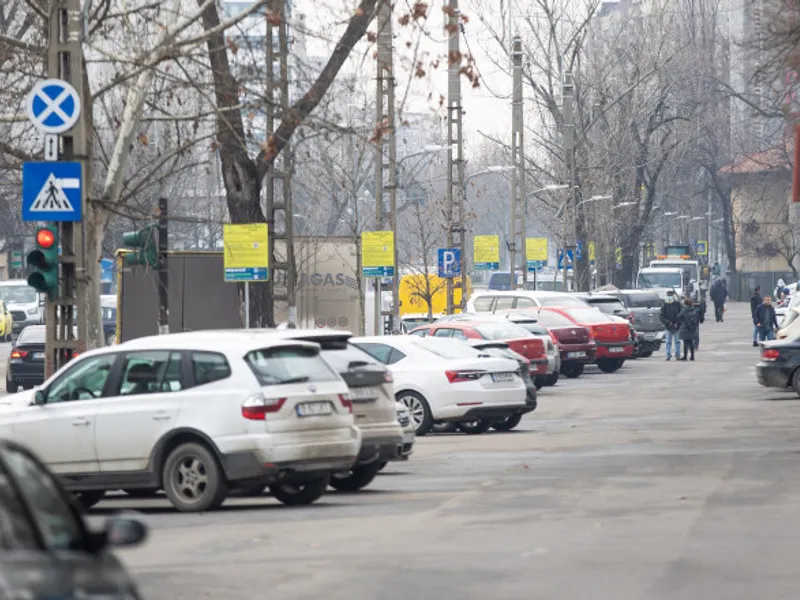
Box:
[222,223,269,281]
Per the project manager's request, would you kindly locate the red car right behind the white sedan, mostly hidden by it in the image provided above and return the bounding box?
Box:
[409,320,547,377]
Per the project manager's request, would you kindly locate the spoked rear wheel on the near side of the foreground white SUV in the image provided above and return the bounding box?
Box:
[163,442,228,512]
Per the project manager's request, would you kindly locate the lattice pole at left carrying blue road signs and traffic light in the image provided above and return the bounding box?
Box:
[45,0,91,377]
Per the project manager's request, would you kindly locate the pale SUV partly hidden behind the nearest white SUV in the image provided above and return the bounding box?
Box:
[271,329,408,491]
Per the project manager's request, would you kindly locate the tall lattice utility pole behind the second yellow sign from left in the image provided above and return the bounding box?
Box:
[375,0,400,335]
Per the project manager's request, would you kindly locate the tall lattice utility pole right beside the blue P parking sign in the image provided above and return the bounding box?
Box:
[445,0,468,315]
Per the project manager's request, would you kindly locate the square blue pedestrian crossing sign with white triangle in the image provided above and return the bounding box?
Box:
[22,162,83,221]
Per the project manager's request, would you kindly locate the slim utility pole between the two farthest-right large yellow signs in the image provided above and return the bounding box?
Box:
[508,35,528,290]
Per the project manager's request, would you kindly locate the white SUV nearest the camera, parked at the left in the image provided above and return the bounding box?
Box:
[0,333,361,511]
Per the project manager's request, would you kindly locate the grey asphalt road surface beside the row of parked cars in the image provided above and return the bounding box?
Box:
[14,305,800,600]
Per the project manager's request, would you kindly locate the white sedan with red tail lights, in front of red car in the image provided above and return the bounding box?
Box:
[350,336,527,435]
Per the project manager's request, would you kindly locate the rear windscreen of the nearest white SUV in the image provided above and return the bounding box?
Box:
[245,346,339,386]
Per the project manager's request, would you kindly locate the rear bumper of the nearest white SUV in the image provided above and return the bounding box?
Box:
[217,426,362,484]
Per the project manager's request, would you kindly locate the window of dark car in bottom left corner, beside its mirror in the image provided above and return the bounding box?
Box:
[3,448,86,550]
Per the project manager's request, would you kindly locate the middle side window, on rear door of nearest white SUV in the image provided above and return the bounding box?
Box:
[114,350,182,396]
